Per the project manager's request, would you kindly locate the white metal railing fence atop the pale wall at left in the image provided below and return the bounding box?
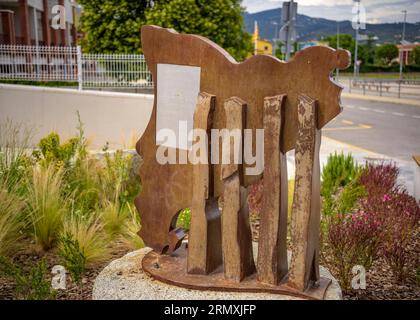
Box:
[0,45,153,89]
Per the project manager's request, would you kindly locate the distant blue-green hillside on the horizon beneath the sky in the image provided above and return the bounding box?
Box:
[244,8,420,43]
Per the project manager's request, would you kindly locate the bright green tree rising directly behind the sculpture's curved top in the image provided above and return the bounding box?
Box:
[146,0,252,60]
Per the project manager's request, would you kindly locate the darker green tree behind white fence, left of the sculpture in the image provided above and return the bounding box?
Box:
[79,0,151,53]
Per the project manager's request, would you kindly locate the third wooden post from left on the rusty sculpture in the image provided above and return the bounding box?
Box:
[257,95,287,285]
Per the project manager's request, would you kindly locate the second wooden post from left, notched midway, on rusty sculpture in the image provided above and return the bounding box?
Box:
[221,97,255,282]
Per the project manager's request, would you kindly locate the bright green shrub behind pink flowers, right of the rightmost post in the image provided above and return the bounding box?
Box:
[321,152,360,197]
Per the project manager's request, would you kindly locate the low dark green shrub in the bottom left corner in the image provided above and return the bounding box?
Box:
[0,256,55,300]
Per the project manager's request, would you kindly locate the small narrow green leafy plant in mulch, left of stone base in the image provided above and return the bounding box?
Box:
[58,233,86,285]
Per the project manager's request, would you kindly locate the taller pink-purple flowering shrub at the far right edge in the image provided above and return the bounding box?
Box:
[360,163,420,281]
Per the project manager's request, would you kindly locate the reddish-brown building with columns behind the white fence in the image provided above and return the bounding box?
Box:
[0,0,80,46]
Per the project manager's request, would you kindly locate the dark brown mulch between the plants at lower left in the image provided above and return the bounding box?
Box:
[0,241,127,300]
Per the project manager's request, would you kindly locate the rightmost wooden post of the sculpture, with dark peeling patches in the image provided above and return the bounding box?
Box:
[288,94,321,291]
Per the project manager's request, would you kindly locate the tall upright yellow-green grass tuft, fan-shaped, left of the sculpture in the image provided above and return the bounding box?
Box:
[27,165,67,250]
